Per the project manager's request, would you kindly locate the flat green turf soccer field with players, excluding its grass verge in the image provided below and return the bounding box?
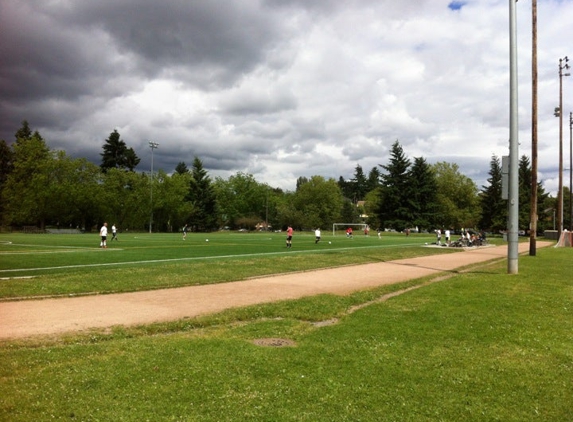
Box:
[0,232,434,278]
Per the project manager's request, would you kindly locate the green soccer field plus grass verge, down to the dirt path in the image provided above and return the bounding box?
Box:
[0,232,459,299]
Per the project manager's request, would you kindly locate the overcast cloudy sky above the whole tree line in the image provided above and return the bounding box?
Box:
[0,0,573,192]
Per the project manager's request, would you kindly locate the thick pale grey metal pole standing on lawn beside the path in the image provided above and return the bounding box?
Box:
[507,0,519,274]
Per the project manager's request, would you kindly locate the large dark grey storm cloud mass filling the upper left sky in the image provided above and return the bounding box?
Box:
[0,0,284,140]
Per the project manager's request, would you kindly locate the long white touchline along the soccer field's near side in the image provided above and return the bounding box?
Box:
[0,243,420,274]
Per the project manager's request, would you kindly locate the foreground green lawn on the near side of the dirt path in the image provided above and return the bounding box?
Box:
[0,248,573,421]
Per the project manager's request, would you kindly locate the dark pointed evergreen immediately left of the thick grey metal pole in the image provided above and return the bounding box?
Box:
[479,155,507,232]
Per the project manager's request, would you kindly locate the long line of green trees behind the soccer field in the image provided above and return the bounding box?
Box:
[0,121,569,232]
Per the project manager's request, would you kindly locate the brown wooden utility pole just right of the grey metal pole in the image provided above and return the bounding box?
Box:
[529,0,537,256]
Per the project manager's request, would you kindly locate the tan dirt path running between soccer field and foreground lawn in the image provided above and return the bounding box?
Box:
[0,241,553,339]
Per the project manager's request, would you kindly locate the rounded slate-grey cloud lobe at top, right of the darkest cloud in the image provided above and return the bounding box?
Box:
[43,0,284,86]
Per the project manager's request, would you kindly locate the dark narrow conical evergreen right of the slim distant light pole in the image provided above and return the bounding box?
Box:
[187,157,217,231]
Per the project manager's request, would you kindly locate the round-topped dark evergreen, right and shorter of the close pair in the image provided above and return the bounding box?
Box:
[408,157,438,229]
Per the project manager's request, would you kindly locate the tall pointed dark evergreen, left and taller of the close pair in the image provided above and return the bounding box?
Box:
[378,141,413,231]
